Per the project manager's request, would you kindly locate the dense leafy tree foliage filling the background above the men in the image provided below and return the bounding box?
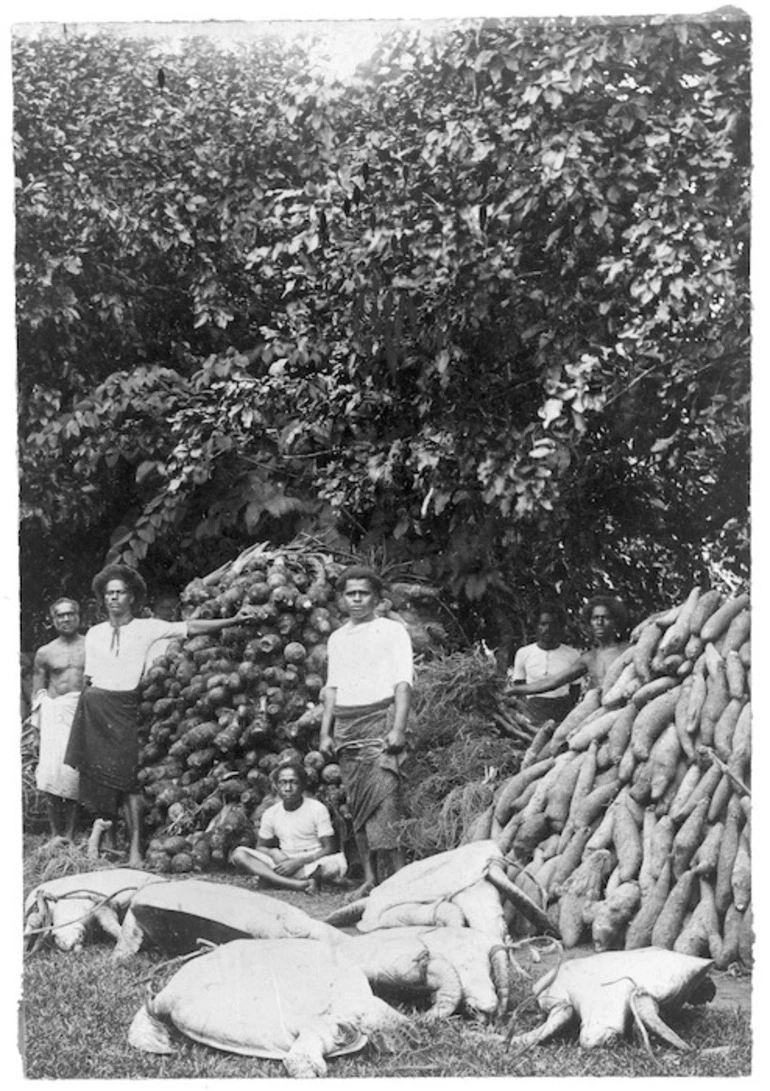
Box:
[14,16,749,642]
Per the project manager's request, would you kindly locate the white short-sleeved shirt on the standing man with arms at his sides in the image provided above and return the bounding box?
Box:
[326,618,413,708]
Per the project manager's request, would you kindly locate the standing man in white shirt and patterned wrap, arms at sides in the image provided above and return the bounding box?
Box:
[320,565,413,898]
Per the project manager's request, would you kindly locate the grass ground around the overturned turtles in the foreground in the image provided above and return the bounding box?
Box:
[21,833,751,1080]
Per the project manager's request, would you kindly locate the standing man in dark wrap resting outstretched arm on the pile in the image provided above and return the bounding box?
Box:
[65,564,257,867]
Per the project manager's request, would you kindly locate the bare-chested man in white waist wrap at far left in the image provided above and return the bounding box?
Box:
[32,598,85,840]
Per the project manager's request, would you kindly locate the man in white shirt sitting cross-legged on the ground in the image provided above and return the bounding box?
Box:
[230,762,348,894]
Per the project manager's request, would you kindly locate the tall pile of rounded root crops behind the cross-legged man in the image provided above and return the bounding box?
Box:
[140,541,446,873]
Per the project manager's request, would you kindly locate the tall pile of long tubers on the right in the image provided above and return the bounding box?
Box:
[477,589,753,969]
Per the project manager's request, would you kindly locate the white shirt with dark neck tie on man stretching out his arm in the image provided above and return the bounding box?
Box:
[85,618,188,690]
